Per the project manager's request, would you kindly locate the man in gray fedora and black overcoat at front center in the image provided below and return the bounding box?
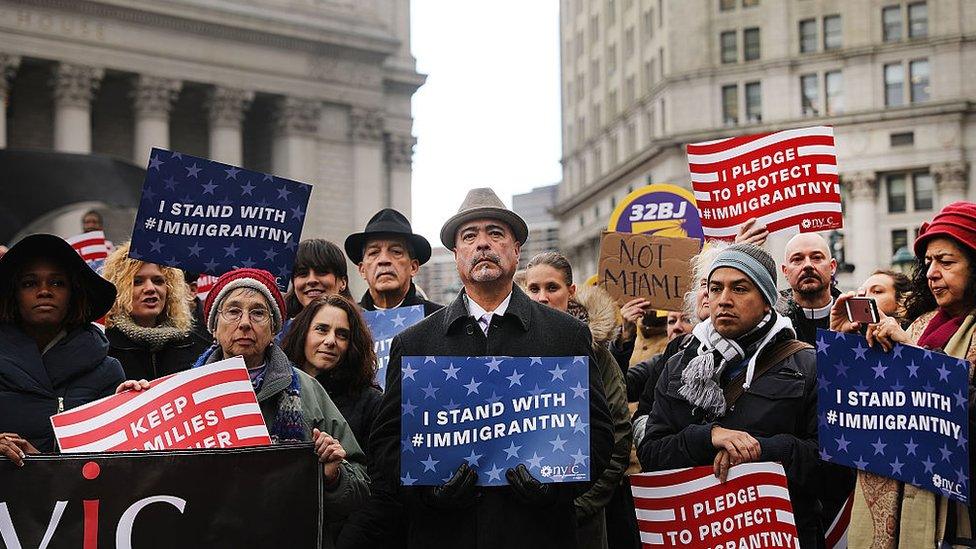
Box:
[339,189,613,549]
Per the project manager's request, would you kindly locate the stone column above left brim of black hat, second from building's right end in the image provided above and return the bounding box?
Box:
[349,108,384,227]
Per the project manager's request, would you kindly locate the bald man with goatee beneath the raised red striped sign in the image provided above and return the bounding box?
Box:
[776,233,840,345]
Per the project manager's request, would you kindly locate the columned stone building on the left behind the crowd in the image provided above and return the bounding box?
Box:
[0,0,424,266]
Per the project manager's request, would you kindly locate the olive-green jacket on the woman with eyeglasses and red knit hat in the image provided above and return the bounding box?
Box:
[201,344,369,548]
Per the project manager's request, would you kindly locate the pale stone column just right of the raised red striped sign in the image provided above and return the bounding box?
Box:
[843,172,887,272]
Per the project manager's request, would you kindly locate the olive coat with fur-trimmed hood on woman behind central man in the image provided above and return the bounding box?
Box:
[569,286,633,547]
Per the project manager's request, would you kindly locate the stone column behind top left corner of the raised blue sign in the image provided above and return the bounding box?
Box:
[130,75,183,166]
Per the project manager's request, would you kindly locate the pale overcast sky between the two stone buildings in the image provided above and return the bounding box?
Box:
[411,0,562,246]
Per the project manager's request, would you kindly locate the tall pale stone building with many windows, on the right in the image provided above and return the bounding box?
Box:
[556,0,976,287]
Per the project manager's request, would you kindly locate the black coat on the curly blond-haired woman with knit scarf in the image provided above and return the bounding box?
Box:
[105,327,210,380]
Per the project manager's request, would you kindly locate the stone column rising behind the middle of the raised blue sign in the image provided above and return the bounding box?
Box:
[206,86,254,166]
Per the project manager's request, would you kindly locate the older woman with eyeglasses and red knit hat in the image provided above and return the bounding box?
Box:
[197,269,369,547]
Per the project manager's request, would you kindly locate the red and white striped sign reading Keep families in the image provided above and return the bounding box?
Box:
[51,357,271,453]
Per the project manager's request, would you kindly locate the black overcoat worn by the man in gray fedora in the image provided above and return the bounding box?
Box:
[339,286,613,549]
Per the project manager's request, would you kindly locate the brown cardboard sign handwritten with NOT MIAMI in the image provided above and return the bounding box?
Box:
[598,233,701,311]
